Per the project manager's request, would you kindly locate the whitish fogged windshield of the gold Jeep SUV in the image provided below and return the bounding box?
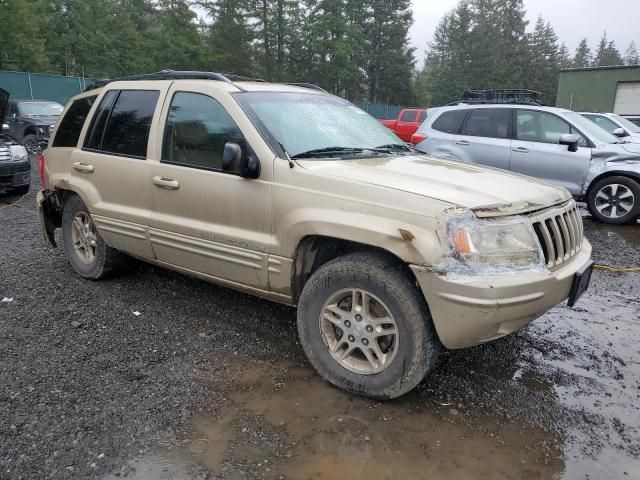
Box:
[235,92,412,158]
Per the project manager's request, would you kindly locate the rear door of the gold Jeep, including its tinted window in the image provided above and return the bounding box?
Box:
[70,82,168,257]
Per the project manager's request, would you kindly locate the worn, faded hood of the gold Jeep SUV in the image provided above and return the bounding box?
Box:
[298,155,571,216]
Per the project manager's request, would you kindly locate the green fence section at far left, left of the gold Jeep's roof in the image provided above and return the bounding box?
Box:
[0,70,94,105]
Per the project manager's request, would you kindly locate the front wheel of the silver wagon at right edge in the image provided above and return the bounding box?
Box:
[587,176,640,225]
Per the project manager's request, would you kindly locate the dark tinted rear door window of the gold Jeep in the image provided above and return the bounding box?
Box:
[86,90,160,158]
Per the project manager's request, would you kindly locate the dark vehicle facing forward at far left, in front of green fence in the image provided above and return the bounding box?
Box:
[5,100,64,153]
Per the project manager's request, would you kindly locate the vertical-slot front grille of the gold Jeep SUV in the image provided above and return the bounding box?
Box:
[530,200,584,268]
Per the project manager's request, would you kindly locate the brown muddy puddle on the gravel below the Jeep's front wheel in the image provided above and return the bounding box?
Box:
[111,362,564,480]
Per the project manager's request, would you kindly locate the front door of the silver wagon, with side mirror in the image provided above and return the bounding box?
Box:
[511,109,591,196]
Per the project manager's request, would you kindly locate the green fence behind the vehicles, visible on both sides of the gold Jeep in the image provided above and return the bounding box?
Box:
[0,70,405,119]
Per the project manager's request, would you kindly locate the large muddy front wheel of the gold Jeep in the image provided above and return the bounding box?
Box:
[298,253,440,399]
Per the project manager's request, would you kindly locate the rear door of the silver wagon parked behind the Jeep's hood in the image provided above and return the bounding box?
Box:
[452,108,511,170]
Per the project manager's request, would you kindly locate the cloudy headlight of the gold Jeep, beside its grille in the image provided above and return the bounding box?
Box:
[447,215,544,273]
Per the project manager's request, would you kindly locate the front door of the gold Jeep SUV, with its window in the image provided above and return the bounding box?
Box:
[148,87,271,290]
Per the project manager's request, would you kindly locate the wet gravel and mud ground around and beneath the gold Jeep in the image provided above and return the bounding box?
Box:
[0,158,640,480]
